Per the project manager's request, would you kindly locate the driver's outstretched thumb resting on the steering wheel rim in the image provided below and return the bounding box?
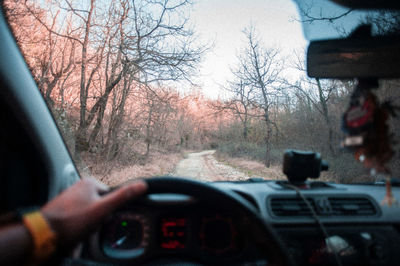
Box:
[99,181,147,213]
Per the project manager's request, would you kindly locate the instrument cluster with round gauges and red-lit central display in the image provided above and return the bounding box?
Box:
[97,208,246,261]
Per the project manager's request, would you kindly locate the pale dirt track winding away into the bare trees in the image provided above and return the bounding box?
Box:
[173,150,249,181]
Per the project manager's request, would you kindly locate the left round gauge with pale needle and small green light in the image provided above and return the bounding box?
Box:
[101,213,150,259]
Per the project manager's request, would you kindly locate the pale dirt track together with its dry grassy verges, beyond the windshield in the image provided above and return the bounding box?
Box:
[93,150,285,186]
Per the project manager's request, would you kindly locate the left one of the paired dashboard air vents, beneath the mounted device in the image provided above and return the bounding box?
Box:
[271,198,315,216]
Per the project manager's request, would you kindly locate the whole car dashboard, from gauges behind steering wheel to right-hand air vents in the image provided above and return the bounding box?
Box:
[85,180,400,265]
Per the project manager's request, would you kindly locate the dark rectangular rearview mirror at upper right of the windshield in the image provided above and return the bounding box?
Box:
[307,36,400,79]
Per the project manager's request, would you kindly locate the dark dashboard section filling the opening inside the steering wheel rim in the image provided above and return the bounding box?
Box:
[91,194,261,264]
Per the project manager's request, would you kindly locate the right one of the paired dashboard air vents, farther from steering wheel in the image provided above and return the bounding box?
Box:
[329,197,377,216]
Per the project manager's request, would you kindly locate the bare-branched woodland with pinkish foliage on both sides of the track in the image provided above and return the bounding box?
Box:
[4,0,400,184]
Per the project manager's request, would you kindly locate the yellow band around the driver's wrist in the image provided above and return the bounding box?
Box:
[22,211,57,263]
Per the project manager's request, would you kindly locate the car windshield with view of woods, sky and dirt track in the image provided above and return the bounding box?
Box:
[3,0,400,185]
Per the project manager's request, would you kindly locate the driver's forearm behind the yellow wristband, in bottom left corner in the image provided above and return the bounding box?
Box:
[0,223,32,265]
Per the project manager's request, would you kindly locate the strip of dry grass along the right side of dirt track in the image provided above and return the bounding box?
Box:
[216,152,286,180]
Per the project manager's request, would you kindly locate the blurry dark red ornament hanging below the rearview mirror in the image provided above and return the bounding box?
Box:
[342,79,396,206]
